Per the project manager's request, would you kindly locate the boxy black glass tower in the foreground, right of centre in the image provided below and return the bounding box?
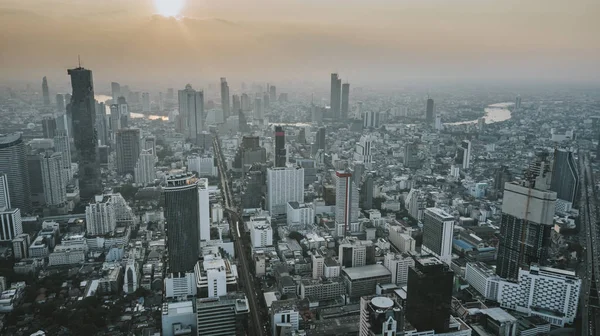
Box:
[406,258,454,334]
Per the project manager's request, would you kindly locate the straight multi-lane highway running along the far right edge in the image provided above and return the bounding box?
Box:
[579,152,600,336]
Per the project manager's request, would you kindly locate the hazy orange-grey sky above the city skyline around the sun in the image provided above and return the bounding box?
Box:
[0,0,600,85]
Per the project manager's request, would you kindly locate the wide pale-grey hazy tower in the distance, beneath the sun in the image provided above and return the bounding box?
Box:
[179,84,204,142]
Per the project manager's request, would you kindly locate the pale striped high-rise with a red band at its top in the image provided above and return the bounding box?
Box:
[335,171,360,232]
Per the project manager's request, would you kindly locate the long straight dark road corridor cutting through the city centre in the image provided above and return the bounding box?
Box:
[213,133,267,336]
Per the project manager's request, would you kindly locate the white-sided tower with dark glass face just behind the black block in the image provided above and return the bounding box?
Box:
[422,208,454,265]
